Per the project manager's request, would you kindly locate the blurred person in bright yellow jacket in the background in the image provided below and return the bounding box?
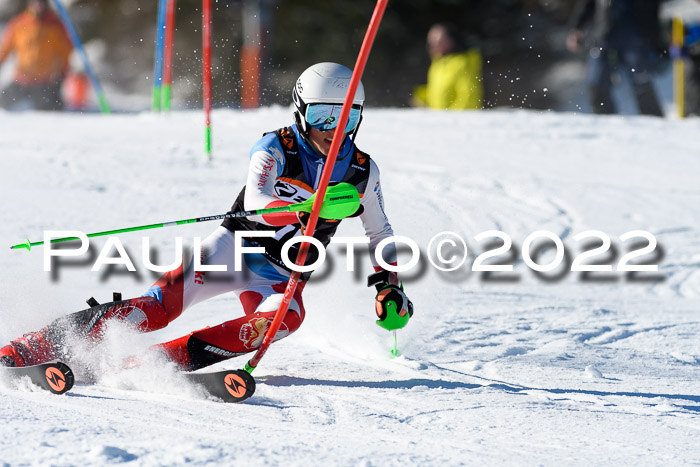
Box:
[413,24,484,110]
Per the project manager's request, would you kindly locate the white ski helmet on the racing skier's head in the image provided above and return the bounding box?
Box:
[292,62,365,133]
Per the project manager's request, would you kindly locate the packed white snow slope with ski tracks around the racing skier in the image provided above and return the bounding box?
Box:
[0,108,700,466]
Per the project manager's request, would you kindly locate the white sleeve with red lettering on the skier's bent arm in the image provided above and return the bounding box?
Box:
[243,146,284,225]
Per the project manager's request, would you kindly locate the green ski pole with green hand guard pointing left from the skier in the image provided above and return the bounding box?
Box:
[10,183,360,251]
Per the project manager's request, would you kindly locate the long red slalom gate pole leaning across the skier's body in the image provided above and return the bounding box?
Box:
[244,0,389,373]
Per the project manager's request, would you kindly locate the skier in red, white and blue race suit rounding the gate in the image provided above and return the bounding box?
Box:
[0,63,413,370]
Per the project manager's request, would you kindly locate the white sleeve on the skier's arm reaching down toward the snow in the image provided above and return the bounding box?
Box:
[360,159,396,266]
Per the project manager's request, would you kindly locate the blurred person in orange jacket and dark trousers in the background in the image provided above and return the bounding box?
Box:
[0,0,73,110]
